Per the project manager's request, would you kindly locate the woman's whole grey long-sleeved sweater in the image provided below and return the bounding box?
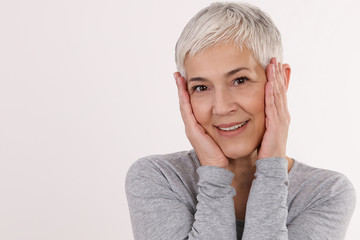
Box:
[126,150,355,240]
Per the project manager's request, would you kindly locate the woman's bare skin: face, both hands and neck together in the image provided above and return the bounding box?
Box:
[174,44,293,219]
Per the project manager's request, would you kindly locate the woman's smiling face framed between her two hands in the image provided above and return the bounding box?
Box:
[185,44,267,159]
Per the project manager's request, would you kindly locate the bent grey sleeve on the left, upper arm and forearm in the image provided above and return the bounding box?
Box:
[126,157,236,240]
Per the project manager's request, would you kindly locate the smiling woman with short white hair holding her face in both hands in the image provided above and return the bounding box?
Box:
[126,3,355,240]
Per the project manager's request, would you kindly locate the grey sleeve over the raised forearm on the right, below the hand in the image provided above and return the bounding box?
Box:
[242,158,289,240]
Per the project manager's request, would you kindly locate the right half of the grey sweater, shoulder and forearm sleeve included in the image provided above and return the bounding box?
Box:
[242,158,355,240]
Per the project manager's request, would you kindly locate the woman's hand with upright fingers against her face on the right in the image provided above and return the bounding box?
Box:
[258,58,290,159]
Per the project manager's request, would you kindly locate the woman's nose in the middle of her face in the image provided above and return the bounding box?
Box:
[213,90,236,115]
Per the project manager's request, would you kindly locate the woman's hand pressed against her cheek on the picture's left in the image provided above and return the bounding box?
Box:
[174,72,229,169]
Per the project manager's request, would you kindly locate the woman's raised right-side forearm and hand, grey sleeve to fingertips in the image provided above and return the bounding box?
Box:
[243,58,290,240]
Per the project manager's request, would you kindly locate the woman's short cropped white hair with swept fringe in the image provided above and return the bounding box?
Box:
[175,2,282,77]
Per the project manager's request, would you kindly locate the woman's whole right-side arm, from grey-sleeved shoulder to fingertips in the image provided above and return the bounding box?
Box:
[243,59,355,240]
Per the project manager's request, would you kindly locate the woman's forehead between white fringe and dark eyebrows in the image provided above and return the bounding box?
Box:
[184,44,262,78]
